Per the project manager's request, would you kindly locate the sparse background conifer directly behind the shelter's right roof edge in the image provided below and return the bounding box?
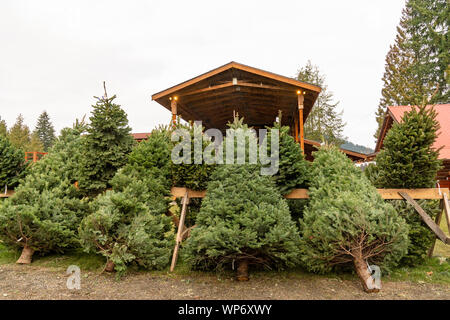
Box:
[297,61,345,146]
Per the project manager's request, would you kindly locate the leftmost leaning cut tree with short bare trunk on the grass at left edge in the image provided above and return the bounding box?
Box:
[0,121,87,263]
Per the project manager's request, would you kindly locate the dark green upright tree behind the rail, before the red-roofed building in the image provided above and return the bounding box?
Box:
[367,106,441,266]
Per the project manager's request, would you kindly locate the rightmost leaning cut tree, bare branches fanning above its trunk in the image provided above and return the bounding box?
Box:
[301,146,408,292]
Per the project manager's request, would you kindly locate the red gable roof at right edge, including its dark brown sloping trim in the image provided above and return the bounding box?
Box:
[375,104,450,159]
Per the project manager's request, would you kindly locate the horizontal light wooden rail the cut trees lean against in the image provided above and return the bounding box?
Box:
[172,187,449,200]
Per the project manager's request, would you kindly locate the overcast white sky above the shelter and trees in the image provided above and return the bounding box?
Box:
[0,0,405,147]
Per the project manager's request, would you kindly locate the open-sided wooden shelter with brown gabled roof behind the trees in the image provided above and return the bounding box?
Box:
[152,62,321,150]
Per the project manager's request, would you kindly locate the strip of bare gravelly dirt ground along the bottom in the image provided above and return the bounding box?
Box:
[0,265,450,300]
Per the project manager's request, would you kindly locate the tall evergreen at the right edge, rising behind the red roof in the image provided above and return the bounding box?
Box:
[374,0,450,139]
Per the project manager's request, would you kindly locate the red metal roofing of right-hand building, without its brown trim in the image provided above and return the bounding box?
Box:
[388,104,450,159]
